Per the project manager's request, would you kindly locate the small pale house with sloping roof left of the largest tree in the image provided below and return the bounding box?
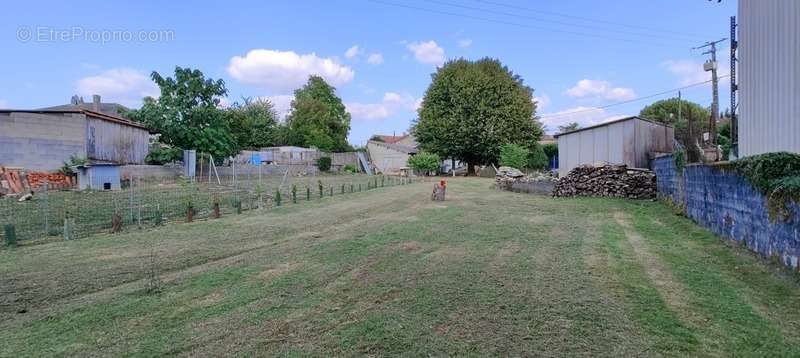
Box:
[367,134,417,174]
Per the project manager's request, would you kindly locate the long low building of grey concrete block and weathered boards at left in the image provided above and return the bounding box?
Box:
[0,109,150,171]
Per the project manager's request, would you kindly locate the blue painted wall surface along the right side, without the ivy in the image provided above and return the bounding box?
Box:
[652,155,800,269]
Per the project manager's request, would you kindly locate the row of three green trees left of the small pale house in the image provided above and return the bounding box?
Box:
[123,67,353,164]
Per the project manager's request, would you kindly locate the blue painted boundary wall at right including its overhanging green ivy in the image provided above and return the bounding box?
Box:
[653,153,800,270]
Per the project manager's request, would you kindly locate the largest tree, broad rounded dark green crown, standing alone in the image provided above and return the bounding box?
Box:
[412,58,542,175]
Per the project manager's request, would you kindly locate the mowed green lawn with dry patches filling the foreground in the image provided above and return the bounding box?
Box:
[0,179,800,357]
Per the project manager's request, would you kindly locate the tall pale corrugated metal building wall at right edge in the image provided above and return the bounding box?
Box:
[737,0,800,156]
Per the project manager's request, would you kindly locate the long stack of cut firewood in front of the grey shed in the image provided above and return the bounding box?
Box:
[553,164,656,199]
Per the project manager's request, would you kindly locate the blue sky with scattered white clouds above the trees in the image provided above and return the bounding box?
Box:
[0,0,736,145]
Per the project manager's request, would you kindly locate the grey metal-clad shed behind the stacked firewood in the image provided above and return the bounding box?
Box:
[555,116,675,176]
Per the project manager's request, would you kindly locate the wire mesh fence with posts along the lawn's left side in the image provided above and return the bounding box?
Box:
[0,169,418,241]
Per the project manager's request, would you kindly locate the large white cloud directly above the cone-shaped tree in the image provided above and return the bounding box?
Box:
[223,49,355,93]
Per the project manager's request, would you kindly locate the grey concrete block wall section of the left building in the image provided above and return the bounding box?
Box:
[0,112,86,171]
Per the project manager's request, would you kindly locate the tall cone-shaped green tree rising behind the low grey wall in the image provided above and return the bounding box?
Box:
[281,75,351,151]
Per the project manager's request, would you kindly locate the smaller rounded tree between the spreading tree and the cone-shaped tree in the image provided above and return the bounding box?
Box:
[226,98,278,149]
